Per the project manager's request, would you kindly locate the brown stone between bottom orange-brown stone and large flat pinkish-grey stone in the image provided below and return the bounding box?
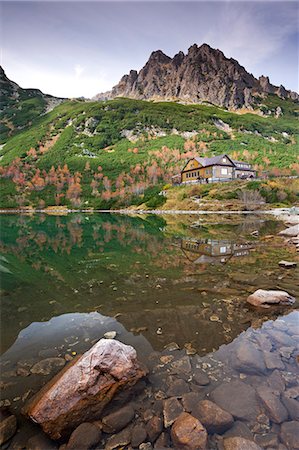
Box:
[192,400,234,434]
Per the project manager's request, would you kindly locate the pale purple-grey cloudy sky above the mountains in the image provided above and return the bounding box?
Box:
[0,0,299,98]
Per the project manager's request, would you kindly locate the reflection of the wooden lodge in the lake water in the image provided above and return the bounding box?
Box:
[181,238,255,264]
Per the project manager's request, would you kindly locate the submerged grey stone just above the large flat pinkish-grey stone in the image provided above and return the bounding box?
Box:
[233,339,266,374]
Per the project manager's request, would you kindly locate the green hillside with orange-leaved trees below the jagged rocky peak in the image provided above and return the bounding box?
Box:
[0,95,299,208]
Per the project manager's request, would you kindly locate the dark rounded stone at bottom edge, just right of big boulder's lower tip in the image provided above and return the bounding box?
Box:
[65,422,102,450]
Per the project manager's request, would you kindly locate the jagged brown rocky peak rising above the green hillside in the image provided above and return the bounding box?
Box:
[96,44,299,109]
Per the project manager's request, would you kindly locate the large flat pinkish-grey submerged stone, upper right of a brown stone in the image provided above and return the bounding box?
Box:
[210,380,260,420]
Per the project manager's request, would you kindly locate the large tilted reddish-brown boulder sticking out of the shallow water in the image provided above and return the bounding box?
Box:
[25,339,146,439]
